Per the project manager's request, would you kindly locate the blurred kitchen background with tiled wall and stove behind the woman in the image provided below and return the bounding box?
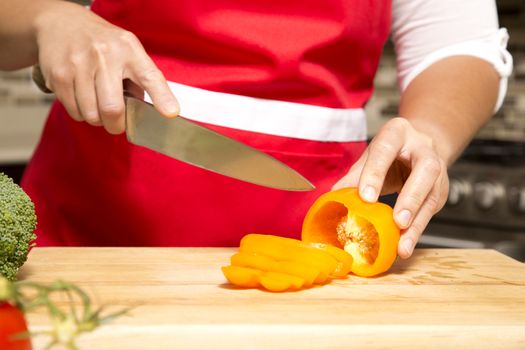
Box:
[0,0,525,261]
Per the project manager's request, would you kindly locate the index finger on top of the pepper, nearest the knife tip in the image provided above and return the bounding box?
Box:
[359,118,408,202]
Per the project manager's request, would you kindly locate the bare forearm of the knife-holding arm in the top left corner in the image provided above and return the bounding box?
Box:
[0,0,80,70]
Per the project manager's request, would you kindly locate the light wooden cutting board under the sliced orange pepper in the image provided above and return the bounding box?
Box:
[21,248,525,350]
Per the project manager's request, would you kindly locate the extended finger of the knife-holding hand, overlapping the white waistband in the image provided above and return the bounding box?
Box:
[126,53,180,117]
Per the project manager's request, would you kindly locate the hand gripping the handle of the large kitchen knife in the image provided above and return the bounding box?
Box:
[35,1,179,134]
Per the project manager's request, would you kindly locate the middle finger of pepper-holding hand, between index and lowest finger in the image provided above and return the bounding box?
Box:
[394,153,443,228]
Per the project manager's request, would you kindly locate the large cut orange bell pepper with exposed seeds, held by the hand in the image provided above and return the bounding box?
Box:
[302,188,400,277]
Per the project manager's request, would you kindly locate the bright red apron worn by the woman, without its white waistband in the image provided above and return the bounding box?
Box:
[23,0,391,246]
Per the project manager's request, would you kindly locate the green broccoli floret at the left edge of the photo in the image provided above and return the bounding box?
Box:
[0,173,36,281]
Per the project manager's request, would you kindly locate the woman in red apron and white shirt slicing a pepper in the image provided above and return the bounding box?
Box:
[0,0,512,258]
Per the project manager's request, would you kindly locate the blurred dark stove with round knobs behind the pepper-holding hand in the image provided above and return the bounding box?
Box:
[420,140,525,261]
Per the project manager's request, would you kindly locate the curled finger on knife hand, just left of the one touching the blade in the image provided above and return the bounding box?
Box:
[75,71,102,126]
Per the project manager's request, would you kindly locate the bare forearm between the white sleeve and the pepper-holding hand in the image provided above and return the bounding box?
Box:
[399,56,499,164]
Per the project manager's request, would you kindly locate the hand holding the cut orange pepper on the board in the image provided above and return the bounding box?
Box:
[333,118,449,259]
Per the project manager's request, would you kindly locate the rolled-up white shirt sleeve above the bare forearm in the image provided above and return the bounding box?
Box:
[392,0,512,110]
